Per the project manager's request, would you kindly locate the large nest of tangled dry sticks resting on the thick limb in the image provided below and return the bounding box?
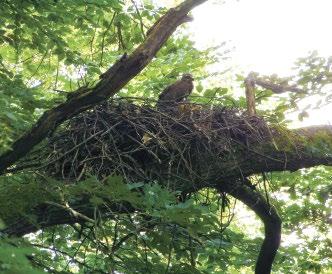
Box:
[37,98,271,191]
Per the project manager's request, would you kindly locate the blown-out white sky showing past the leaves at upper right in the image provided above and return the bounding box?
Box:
[184,0,332,125]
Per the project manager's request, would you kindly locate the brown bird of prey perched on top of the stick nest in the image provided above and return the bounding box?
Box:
[157,73,194,109]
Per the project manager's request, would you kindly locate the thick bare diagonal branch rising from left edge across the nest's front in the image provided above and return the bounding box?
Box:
[0,0,207,174]
